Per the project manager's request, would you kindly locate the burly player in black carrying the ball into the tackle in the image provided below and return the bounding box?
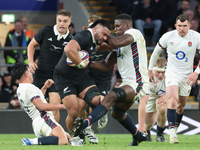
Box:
[53,19,112,139]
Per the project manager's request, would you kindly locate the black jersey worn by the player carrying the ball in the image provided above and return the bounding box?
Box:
[55,30,96,78]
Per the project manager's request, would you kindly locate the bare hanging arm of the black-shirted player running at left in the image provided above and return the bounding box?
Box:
[27,38,39,73]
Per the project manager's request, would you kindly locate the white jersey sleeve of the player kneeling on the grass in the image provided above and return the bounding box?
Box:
[25,85,40,102]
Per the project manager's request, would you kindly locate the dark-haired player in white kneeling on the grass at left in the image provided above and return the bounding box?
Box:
[11,62,82,146]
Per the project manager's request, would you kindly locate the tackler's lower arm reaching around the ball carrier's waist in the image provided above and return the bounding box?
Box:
[90,51,117,71]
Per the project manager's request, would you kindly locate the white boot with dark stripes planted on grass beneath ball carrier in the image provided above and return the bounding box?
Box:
[83,126,99,144]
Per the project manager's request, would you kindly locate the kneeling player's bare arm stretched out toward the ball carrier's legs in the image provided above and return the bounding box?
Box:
[32,98,65,111]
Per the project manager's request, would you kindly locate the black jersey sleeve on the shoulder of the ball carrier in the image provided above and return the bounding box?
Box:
[73,30,92,50]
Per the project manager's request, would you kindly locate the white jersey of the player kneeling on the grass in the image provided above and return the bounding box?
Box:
[17,83,53,120]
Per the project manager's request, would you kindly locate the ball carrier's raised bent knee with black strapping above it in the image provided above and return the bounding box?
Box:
[83,86,100,107]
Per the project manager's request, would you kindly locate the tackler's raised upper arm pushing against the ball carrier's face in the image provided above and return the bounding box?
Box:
[106,34,134,48]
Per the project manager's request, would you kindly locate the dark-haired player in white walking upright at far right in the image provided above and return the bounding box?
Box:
[148,14,200,144]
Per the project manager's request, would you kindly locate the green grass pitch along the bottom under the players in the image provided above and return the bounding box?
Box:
[0,134,200,150]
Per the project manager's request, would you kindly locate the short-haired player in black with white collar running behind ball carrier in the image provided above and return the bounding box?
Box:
[28,10,72,122]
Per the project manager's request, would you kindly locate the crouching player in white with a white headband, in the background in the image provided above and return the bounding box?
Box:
[145,57,168,142]
